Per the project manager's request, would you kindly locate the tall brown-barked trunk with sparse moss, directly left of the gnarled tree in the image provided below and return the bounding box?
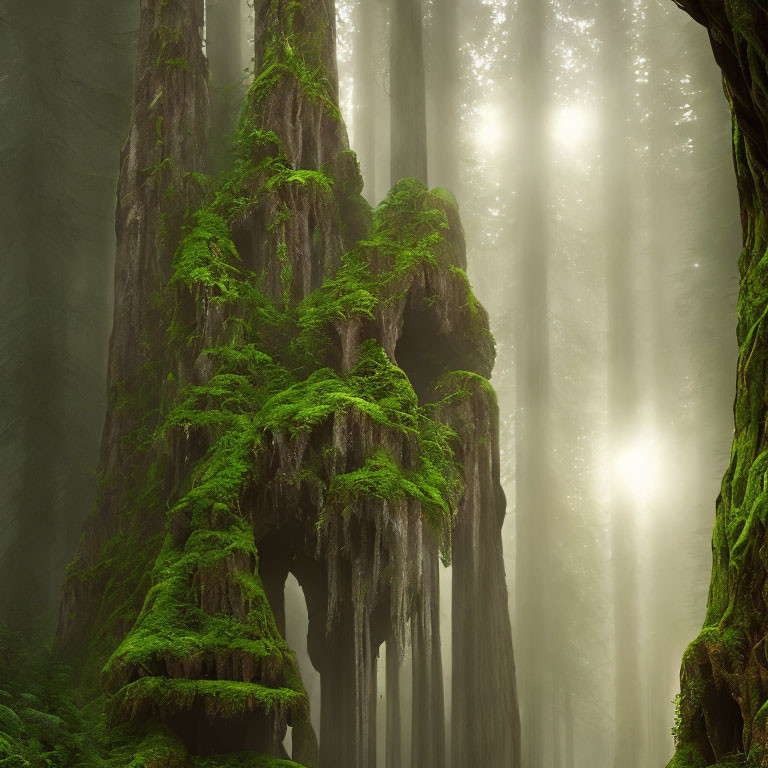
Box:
[58,0,208,655]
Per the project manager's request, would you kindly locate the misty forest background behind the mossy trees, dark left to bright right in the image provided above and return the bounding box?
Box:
[0,0,740,768]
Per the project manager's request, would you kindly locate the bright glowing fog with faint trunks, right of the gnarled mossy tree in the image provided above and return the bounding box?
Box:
[339,0,741,768]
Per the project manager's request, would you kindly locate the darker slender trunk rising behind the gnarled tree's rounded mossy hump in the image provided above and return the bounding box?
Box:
[389,0,427,184]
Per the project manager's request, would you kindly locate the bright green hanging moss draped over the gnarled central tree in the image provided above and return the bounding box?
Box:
[52,0,510,768]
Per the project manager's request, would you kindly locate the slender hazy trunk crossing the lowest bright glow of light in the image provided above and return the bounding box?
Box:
[601,3,645,768]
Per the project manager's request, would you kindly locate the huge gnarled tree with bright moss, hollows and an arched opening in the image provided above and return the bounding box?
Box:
[61,0,518,768]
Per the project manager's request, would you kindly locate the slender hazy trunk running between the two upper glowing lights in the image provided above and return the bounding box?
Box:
[512,0,554,768]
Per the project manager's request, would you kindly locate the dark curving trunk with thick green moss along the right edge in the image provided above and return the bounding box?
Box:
[670,0,768,768]
